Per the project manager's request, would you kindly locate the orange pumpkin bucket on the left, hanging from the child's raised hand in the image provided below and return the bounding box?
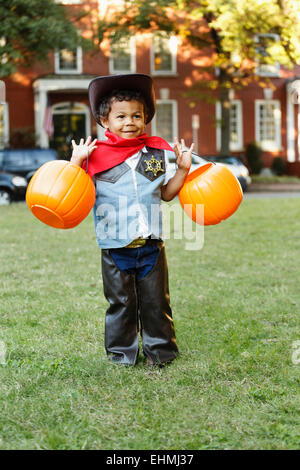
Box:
[26,160,96,229]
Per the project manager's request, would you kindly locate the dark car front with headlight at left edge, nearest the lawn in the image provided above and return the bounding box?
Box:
[0,171,27,206]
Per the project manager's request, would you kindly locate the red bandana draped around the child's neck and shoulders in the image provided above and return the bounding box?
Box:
[82,131,173,177]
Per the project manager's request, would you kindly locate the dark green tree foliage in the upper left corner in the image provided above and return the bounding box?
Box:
[0,0,88,77]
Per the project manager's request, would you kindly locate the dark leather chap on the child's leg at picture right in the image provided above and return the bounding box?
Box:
[137,242,178,364]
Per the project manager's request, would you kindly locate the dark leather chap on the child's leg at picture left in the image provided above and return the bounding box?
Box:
[102,250,139,365]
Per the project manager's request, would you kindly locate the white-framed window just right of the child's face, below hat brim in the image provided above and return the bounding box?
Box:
[152,100,178,142]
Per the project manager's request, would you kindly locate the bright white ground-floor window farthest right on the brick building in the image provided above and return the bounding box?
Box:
[255,100,281,151]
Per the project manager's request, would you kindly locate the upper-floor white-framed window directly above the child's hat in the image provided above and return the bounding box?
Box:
[109,36,135,73]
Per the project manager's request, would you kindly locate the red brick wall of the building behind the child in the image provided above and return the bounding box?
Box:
[6,0,300,173]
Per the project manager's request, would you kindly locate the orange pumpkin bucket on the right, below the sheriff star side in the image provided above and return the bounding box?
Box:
[179,162,243,225]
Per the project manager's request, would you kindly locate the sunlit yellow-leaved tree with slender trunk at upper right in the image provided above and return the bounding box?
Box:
[98,0,300,155]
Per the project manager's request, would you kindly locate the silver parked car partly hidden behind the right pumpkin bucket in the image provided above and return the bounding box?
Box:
[169,153,251,191]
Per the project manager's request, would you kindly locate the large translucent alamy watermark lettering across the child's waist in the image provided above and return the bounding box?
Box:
[95,196,204,251]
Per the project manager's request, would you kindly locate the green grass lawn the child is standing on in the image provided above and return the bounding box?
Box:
[0,198,300,450]
